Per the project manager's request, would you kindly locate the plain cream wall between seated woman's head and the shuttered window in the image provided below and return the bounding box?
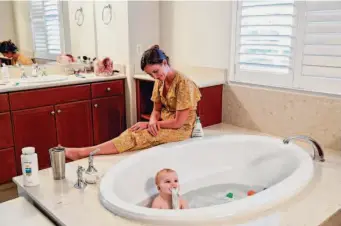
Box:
[160,1,231,68]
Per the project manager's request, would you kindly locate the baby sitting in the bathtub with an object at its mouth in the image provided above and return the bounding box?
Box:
[152,169,188,209]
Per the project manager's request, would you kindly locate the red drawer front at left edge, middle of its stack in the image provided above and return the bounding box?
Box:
[0,112,13,149]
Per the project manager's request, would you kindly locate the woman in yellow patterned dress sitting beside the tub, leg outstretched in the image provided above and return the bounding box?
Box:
[66,45,201,160]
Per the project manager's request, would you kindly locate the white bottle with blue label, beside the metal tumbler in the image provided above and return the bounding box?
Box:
[21,147,39,186]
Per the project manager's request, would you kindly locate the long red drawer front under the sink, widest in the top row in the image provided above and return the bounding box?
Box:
[9,84,90,110]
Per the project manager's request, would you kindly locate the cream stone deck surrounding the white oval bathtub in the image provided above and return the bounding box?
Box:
[13,124,341,226]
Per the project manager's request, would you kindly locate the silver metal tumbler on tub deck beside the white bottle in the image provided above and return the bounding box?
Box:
[49,147,65,180]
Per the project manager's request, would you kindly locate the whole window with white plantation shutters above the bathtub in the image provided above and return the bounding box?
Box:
[231,0,341,94]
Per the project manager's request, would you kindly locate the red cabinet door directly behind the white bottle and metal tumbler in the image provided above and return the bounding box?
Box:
[12,106,57,171]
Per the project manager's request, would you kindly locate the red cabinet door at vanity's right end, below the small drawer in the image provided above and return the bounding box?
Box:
[92,96,126,145]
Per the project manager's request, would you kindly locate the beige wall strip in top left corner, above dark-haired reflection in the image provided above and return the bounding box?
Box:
[0,1,17,43]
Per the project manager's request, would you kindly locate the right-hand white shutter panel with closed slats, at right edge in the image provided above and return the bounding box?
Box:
[295,1,341,94]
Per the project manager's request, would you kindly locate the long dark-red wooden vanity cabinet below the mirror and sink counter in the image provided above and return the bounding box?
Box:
[0,79,126,179]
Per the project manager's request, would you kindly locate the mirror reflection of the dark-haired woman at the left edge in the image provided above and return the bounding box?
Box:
[0,40,33,65]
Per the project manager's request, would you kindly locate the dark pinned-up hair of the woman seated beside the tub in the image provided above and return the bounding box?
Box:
[141,45,169,71]
